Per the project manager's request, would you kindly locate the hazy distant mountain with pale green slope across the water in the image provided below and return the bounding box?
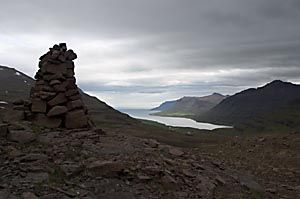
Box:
[156,93,226,117]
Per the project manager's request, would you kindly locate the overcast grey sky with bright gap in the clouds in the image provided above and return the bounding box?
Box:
[0,0,300,108]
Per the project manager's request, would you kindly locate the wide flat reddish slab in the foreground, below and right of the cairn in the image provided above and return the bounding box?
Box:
[86,160,125,176]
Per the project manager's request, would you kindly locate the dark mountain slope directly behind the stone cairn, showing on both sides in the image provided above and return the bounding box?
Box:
[0,66,136,124]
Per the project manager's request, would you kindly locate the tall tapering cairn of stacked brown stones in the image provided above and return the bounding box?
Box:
[30,43,89,129]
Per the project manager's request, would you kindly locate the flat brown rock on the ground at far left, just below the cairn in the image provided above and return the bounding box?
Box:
[7,130,36,144]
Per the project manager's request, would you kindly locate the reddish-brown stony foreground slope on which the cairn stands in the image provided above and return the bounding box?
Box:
[0,119,278,199]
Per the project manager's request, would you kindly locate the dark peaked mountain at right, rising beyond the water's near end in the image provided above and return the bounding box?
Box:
[195,80,300,130]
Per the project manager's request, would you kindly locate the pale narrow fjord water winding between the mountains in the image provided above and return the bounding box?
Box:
[119,109,231,130]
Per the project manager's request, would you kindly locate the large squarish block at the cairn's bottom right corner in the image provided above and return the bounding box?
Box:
[65,110,88,129]
